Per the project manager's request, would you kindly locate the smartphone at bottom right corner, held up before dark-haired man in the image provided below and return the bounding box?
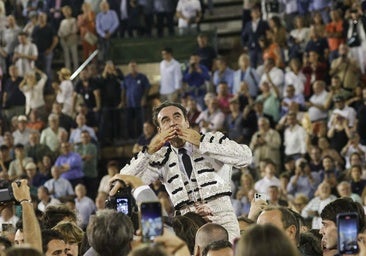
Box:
[337,212,359,255]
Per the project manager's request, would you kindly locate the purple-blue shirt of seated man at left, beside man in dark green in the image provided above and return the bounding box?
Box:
[55,152,84,180]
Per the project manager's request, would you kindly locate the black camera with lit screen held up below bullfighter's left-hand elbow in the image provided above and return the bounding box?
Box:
[105,180,139,230]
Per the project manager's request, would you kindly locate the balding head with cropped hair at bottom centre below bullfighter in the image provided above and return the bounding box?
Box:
[194,223,229,256]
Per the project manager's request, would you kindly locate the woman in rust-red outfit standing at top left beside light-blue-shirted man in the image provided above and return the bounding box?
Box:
[77,2,97,60]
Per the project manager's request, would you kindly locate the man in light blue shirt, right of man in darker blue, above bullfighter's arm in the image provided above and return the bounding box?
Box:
[212,57,234,93]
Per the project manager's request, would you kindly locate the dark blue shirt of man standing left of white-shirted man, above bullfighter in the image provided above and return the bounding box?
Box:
[122,73,150,108]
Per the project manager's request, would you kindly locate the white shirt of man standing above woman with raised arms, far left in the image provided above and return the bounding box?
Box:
[14,42,38,77]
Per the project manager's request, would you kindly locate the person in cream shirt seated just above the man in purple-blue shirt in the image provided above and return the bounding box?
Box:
[41,114,66,152]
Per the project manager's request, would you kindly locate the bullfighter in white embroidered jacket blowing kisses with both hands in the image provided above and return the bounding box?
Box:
[121,102,252,241]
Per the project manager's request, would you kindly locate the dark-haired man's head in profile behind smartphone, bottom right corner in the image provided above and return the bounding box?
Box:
[319,198,365,255]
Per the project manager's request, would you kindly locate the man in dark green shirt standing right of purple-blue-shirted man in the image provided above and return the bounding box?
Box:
[75,130,98,199]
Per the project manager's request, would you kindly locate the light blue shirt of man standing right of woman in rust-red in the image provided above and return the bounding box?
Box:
[96,10,119,37]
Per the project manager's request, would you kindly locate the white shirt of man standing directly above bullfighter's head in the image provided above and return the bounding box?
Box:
[160,59,182,95]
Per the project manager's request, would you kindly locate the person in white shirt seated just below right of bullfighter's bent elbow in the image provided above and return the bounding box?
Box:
[254,160,281,195]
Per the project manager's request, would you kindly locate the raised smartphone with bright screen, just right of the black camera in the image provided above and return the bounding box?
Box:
[140,202,163,243]
